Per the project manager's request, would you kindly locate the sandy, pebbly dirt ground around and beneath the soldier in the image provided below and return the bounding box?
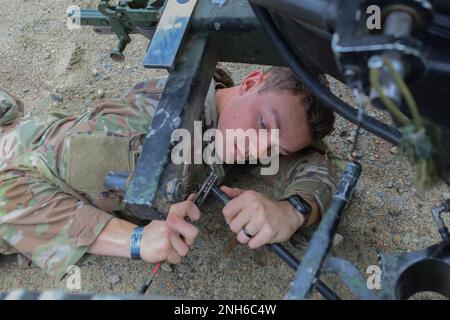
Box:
[0,0,450,299]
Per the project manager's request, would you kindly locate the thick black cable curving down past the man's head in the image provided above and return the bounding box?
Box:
[250,2,401,145]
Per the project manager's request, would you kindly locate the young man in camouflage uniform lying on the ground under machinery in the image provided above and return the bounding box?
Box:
[0,67,336,278]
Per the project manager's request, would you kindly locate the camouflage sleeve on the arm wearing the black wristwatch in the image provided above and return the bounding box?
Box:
[243,149,338,225]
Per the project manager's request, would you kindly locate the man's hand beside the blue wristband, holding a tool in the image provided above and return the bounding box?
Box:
[141,194,201,263]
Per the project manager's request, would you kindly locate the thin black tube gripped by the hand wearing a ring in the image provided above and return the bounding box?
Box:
[211,186,341,300]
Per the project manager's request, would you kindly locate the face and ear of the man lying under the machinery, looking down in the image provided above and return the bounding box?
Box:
[218,71,311,162]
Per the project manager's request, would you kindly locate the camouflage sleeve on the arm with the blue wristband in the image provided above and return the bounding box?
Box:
[0,171,112,279]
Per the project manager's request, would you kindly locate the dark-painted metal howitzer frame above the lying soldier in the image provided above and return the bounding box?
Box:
[70,0,450,299]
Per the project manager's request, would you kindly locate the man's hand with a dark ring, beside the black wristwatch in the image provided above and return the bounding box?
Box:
[221,186,304,249]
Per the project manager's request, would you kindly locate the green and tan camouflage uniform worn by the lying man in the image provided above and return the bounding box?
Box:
[0,71,336,279]
